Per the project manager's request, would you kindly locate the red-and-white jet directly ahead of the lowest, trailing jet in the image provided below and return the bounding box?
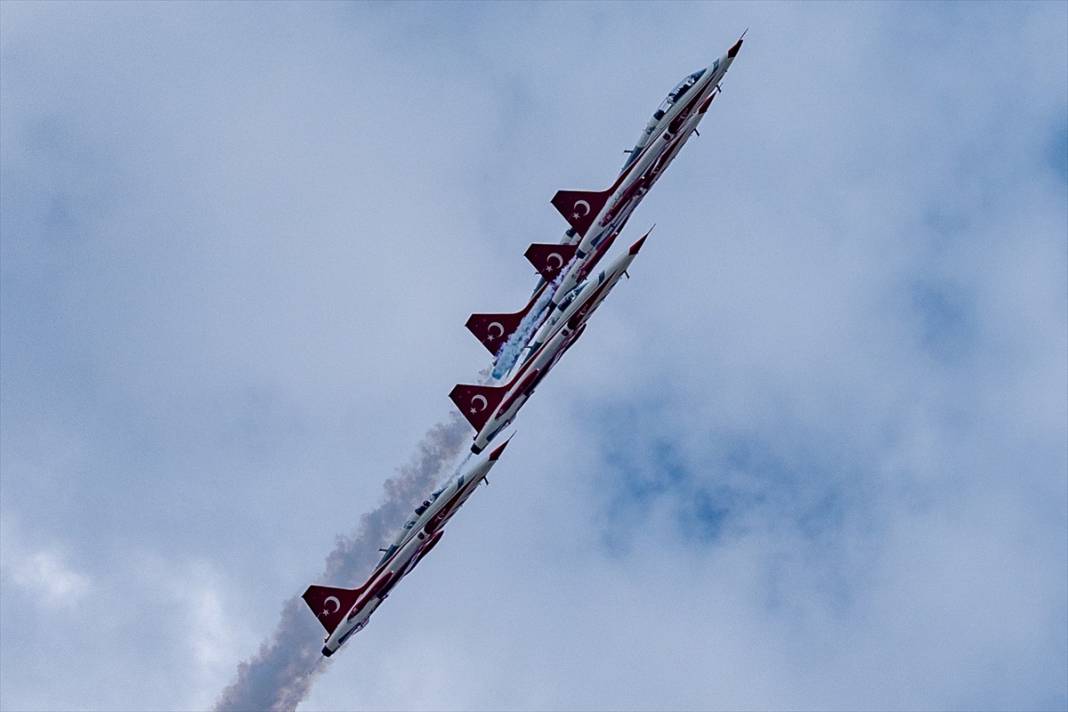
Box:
[449,233,649,454]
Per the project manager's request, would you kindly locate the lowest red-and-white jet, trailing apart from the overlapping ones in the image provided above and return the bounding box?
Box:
[301,441,508,658]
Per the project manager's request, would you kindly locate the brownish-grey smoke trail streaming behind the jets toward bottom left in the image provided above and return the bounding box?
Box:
[215,414,468,712]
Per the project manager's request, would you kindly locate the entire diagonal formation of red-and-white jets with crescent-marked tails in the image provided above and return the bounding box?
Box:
[303,33,744,656]
